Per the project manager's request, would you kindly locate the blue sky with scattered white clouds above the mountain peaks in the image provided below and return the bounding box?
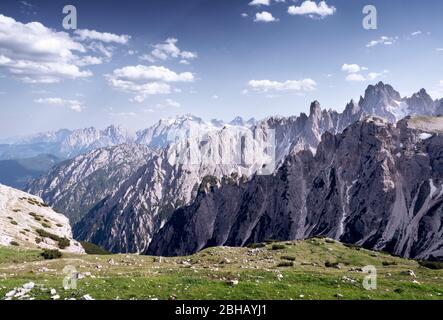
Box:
[0,0,443,138]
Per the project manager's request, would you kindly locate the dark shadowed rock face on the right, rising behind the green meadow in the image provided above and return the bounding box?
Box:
[147,118,443,259]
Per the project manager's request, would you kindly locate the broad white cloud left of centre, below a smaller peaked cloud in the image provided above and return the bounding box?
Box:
[107,65,194,102]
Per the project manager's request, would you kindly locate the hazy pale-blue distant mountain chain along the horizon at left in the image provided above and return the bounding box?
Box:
[0,115,255,160]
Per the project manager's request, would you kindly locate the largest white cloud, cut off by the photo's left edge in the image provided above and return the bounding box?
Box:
[0,14,92,83]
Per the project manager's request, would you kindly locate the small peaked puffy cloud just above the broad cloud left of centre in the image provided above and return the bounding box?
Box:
[140,38,198,63]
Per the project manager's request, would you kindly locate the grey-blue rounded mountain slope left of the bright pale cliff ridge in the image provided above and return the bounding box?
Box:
[26,144,153,223]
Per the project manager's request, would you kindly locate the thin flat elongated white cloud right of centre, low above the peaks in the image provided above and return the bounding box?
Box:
[248,79,317,92]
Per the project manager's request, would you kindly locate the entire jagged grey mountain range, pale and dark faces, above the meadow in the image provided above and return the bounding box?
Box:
[6,82,443,258]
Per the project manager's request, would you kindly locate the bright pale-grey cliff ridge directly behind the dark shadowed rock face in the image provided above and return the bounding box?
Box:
[74,127,284,252]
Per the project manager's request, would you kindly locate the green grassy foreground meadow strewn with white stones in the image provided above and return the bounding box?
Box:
[0,238,443,299]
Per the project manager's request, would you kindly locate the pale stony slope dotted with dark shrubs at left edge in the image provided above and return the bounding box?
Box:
[0,184,84,253]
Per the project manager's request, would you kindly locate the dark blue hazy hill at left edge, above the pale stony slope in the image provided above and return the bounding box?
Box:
[0,154,60,190]
